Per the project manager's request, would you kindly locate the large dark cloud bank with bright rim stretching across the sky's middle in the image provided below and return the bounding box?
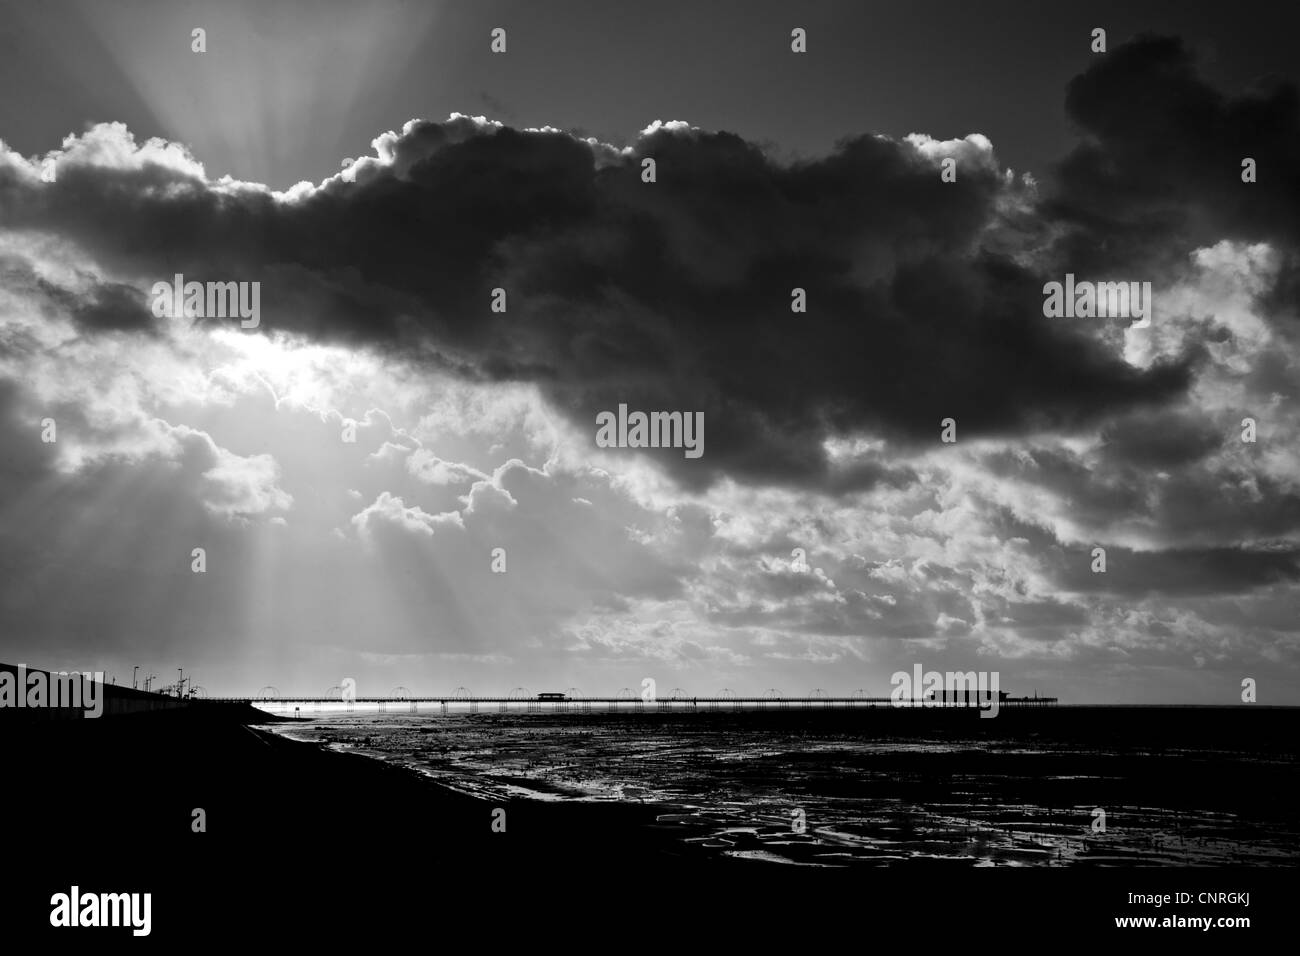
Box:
[0,98,1192,492]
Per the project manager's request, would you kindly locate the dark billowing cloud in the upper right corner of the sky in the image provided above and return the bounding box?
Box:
[1049,36,1300,269]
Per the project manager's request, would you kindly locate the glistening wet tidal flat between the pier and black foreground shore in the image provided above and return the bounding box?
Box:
[268,708,1300,866]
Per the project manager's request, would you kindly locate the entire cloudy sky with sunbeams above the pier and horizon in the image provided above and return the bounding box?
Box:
[0,0,1300,704]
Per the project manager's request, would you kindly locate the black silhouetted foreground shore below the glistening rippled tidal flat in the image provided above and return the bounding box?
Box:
[0,705,1297,944]
